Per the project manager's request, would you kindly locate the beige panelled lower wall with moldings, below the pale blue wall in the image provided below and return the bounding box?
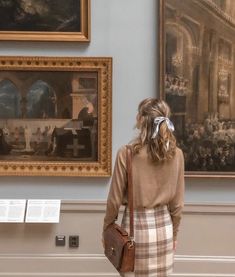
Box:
[0,200,235,277]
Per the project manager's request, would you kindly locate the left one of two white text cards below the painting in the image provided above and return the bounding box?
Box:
[0,199,26,223]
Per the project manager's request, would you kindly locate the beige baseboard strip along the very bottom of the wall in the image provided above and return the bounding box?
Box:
[0,254,235,277]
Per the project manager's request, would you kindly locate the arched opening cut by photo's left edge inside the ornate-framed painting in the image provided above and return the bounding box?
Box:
[0,79,21,118]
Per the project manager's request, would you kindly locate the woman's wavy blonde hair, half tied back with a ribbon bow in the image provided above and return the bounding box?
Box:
[133,98,176,162]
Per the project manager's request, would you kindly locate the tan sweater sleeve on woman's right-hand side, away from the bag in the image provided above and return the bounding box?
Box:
[169,150,185,241]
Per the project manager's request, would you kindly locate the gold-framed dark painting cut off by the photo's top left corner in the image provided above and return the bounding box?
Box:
[0,0,90,41]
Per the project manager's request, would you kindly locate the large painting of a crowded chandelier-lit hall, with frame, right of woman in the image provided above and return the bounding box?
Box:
[159,0,235,178]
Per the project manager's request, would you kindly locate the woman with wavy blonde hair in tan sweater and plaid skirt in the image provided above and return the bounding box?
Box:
[103,98,184,277]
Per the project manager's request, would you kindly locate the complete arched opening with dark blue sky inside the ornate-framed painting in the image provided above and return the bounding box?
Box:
[27,80,57,118]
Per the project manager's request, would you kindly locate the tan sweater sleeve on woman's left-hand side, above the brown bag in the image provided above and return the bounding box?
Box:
[103,147,127,230]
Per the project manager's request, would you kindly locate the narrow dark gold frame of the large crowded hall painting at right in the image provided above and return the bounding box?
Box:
[157,0,235,178]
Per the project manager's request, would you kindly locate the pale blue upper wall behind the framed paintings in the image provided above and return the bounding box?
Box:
[0,0,235,202]
